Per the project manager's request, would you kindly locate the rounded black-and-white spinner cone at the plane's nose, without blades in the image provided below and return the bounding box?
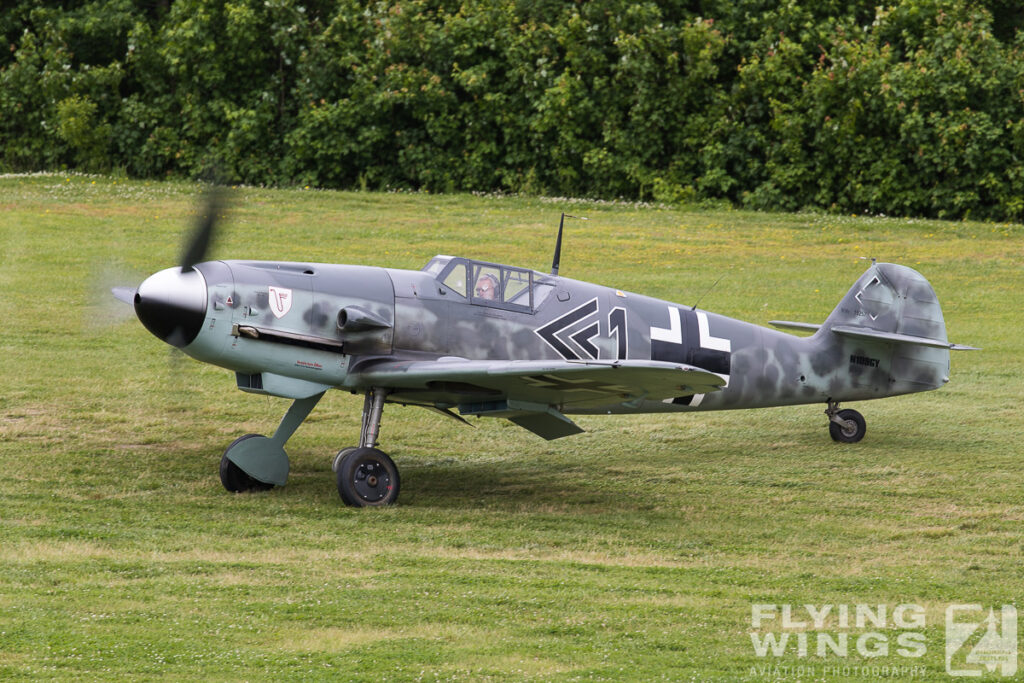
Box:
[134,267,207,348]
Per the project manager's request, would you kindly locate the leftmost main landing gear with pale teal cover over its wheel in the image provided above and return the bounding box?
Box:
[220,392,324,493]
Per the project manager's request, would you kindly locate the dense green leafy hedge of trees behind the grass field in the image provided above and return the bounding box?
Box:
[0,0,1024,219]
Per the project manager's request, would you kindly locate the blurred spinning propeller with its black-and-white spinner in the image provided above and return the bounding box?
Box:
[111,186,223,348]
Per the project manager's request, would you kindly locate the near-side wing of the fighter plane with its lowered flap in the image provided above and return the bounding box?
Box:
[349,358,726,439]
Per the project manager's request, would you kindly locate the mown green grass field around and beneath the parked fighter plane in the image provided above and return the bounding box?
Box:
[0,175,1024,681]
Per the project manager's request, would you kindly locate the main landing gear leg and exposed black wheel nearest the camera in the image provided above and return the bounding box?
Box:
[333,387,399,508]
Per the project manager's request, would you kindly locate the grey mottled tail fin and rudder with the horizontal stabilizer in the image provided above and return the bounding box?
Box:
[815,263,964,394]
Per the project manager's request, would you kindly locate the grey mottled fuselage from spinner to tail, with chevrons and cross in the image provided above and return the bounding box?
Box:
[135,256,948,413]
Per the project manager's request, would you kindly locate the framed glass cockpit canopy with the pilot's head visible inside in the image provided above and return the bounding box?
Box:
[423,256,554,312]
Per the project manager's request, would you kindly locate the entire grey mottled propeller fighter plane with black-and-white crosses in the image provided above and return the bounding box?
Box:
[114,194,972,507]
